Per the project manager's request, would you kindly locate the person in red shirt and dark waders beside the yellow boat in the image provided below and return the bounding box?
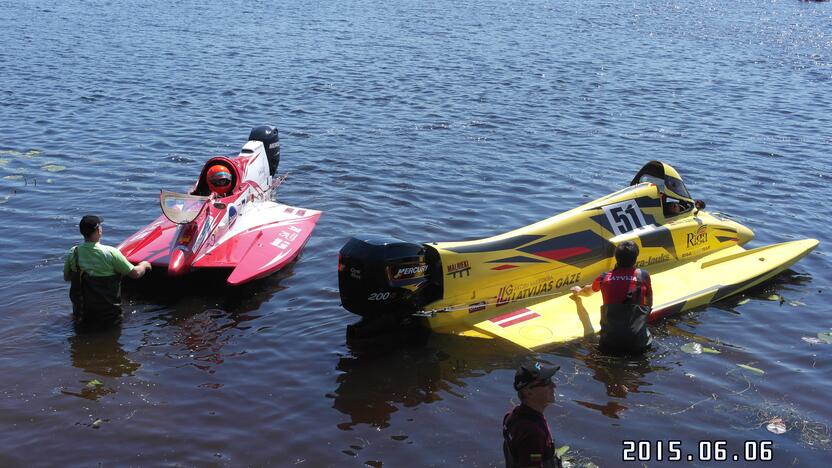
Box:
[572,241,653,354]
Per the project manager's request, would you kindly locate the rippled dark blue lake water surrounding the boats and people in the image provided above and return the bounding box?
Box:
[0,0,832,466]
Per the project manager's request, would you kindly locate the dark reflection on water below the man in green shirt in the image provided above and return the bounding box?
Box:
[62,325,141,400]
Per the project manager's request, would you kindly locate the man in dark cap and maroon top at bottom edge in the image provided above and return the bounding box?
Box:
[503,362,562,468]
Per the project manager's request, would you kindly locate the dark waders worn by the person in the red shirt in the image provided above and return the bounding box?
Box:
[600,269,652,353]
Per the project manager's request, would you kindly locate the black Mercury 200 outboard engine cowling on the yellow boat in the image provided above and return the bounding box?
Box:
[338,236,442,319]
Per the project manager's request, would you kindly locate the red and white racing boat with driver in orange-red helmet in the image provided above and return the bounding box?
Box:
[118,126,321,285]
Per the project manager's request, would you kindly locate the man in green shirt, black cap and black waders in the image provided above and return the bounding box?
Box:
[64,215,151,328]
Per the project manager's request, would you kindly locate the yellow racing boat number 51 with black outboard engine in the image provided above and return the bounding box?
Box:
[338,161,818,349]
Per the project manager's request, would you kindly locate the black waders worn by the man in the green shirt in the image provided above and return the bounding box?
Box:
[69,247,122,328]
